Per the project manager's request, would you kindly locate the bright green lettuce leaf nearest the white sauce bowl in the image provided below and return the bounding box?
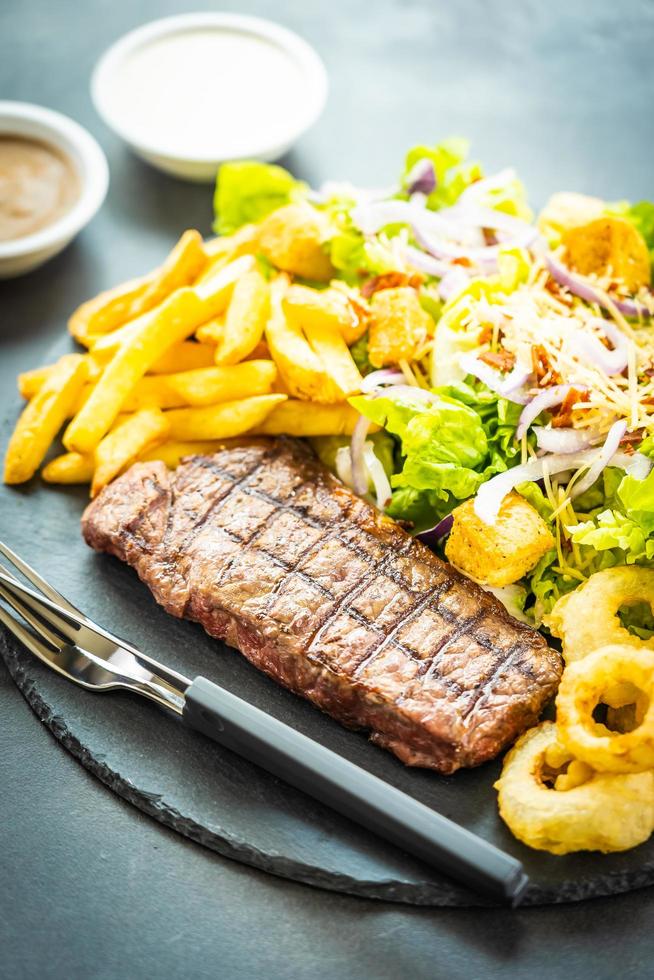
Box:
[213,160,306,235]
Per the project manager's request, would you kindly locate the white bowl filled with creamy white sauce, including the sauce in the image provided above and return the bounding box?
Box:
[91,12,328,181]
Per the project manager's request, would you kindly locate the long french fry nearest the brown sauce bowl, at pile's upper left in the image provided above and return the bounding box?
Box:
[68,230,208,346]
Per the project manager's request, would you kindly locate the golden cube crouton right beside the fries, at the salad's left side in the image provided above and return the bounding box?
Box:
[368,286,434,368]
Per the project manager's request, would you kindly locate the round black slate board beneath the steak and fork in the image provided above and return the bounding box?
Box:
[0,354,654,906]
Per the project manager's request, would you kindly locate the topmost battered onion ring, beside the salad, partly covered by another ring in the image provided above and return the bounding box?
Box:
[545,565,654,664]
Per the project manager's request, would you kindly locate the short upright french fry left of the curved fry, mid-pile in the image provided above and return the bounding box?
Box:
[216,269,270,364]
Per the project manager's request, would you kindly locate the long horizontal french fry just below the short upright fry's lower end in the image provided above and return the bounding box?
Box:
[122,361,277,412]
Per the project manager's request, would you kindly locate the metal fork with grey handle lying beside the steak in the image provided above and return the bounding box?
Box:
[0,542,529,906]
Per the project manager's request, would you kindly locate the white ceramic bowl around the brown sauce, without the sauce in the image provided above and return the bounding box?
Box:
[0,102,109,279]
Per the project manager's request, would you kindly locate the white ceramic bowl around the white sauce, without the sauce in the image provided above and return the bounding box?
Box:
[91,13,328,181]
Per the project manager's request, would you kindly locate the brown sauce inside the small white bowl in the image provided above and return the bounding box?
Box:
[0,135,80,242]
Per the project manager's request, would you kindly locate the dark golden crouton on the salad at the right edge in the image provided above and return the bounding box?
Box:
[563,217,651,293]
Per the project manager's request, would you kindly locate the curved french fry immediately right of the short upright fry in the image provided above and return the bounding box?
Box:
[266,275,343,404]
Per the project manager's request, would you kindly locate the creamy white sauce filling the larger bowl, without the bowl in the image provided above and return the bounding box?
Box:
[109,27,306,159]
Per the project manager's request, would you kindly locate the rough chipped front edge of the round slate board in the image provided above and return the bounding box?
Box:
[5,629,654,908]
